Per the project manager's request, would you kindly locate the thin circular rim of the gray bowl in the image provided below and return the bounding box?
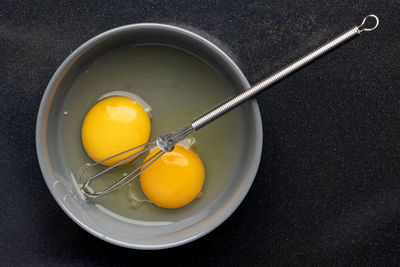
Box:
[36,23,263,250]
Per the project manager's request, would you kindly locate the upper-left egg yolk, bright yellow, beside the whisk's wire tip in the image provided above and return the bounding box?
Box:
[82,96,151,166]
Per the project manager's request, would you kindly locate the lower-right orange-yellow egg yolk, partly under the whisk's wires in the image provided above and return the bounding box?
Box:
[140,145,204,209]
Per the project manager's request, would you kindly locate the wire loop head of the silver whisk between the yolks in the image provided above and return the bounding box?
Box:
[79,125,194,199]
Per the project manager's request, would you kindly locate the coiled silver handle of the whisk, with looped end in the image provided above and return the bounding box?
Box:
[191,15,379,130]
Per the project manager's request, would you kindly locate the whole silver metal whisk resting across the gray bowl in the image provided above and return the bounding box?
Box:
[79,14,379,199]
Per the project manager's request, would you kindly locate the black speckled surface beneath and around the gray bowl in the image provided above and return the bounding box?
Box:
[0,0,400,266]
